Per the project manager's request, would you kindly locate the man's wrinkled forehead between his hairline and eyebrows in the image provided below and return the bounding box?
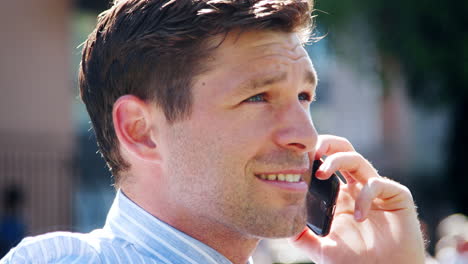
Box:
[196,31,316,93]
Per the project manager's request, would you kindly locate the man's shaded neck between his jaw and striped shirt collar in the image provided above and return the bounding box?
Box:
[122,188,260,264]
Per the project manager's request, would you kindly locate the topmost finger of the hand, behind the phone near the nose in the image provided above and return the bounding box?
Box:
[315,135,354,159]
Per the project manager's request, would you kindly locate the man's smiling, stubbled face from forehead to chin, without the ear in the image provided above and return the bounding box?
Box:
[161,31,317,237]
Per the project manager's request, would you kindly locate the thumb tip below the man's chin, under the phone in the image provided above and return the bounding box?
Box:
[288,227,322,263]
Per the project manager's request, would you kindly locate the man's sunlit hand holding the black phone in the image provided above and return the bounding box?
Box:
[290,136,424,264]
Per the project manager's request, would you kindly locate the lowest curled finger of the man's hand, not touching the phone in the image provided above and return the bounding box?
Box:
[354,177,413,221]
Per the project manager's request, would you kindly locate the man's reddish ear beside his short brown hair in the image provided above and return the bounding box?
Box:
[112,95,160,162]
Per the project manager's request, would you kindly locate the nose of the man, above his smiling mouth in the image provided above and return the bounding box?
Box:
[274,102,318,154]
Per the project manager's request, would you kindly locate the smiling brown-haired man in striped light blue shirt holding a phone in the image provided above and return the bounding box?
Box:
[0,0,424,264]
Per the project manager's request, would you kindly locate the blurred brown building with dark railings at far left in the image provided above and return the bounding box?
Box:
[0,0,74,234]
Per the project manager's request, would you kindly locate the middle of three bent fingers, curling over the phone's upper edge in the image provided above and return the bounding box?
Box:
[315,152,379,184]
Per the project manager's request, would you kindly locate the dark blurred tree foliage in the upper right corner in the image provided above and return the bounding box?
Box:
[316,0,468,214]
